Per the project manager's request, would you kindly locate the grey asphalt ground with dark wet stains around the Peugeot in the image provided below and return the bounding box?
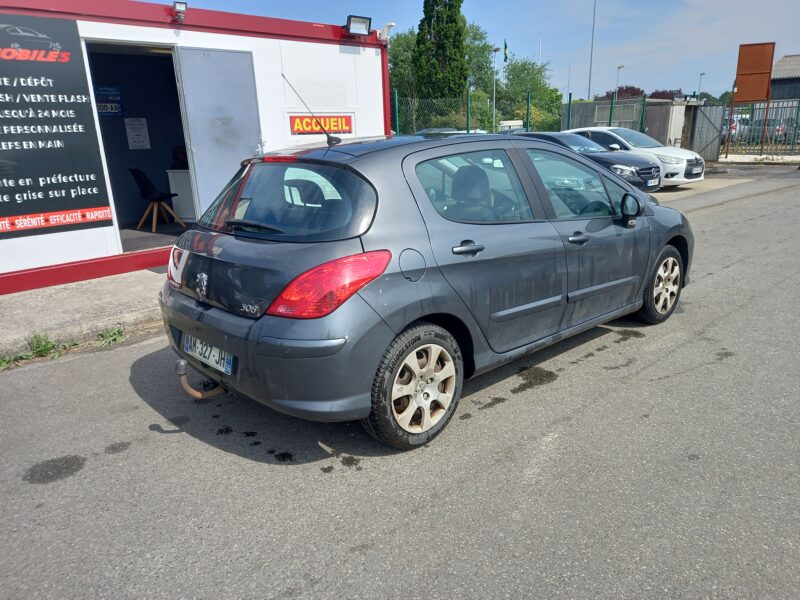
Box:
[0,169,800,598]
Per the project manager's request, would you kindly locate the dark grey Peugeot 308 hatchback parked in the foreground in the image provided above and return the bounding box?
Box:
[161,135,694,449]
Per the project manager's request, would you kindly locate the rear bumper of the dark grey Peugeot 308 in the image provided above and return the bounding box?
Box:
[161,284,394,421]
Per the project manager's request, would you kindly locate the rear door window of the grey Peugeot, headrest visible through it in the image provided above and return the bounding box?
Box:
[416,150,533,223]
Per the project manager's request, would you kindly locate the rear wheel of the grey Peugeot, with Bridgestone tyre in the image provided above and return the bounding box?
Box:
[362,323,464,450]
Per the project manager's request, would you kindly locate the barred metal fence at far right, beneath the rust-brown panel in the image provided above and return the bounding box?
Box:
[720,99,800,155]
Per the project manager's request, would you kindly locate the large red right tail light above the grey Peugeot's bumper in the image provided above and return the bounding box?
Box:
[267,250,392,319]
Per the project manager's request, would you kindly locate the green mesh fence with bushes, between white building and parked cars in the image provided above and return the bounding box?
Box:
[392,90,560,134]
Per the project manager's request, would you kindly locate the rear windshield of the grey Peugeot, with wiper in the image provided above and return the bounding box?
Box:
[197,162,377,242]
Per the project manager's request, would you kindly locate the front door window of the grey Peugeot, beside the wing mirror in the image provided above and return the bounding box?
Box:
[527,150,616,219]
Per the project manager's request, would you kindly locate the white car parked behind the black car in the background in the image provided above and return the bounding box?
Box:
[569,127,706,187]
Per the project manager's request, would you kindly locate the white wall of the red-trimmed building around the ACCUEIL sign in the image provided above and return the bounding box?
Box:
[0,21,384,272]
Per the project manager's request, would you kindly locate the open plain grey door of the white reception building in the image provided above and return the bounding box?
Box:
[176,48,261,216]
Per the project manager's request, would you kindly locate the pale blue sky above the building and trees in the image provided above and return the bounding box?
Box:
[144,0,800,98]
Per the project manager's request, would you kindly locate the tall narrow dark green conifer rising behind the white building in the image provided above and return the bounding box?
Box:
[413,0,469,98]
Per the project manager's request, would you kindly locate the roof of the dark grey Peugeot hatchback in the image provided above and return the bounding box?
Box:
[264,133,528,162]
